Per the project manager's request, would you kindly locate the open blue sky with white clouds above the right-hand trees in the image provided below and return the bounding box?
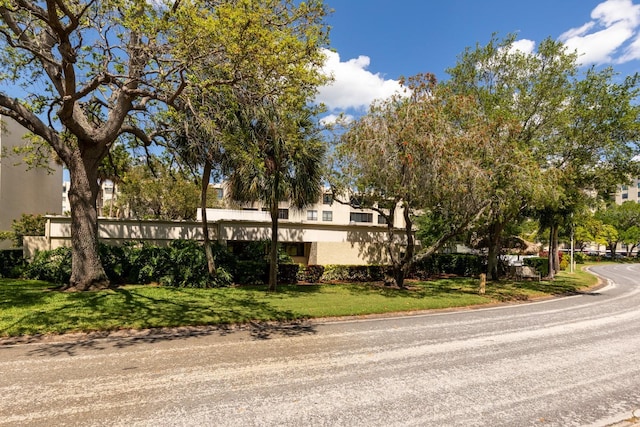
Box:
[317,0,640,122]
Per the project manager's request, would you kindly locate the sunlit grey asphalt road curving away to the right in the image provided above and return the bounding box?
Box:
[0,265,640,426]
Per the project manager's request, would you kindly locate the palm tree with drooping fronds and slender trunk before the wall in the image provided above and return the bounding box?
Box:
[227,100,326,291]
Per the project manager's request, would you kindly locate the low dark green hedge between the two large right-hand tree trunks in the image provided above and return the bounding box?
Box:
[413,253,486,279]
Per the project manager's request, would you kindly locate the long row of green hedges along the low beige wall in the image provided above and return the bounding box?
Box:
[20,244,485,288]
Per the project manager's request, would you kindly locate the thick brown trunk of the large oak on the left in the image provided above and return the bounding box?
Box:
[65,150,109,291]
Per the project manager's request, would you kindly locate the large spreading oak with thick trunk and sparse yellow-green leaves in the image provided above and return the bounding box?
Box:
[0,0,330,290]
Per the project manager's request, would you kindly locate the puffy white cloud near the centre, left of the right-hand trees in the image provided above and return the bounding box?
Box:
[316,50,402,111]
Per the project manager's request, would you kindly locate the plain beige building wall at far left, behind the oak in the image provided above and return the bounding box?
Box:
[0,116,62,231]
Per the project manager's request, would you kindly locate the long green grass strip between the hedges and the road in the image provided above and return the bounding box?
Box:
[0,266,596,337]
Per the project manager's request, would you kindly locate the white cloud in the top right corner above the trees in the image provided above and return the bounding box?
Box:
[559,0,640,65]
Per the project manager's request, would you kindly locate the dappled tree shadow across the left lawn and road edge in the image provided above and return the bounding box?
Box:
[0,286,316,356]
